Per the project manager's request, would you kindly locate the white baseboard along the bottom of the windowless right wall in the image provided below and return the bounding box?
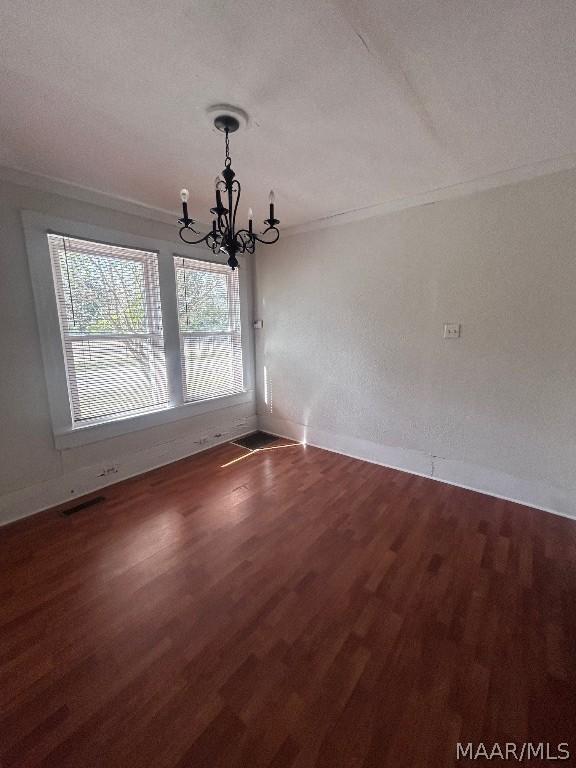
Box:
[258,414,576,519]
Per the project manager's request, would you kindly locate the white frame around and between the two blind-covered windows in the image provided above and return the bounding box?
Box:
[22,211,255,449]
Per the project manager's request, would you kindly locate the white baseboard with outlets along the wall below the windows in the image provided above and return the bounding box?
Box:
[0,416,257,526]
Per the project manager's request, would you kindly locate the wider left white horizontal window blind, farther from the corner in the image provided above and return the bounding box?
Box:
[48,234,169,423]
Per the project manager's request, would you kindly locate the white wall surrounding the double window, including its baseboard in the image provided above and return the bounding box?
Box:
[0,175,256,523]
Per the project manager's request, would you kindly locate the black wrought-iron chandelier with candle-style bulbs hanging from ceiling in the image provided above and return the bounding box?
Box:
[178,112,280,270]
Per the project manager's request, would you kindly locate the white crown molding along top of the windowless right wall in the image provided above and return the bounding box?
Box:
[282,149,576,237]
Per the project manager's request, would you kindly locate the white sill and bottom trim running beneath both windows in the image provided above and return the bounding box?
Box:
[54,390,254,450]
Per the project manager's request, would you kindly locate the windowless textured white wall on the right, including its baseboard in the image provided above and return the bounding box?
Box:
[256,171,576,515]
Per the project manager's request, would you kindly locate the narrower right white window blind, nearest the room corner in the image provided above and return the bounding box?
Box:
[174,257,244,402]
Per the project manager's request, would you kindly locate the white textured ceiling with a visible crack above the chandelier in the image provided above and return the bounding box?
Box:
[0,0,576,225]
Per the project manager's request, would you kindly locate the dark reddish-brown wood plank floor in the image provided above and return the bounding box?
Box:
[0,438,576,768]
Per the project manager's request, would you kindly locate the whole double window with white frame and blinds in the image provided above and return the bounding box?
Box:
[22,211,254,449]
